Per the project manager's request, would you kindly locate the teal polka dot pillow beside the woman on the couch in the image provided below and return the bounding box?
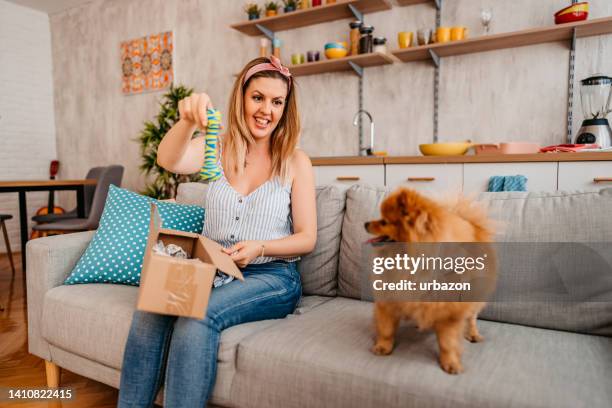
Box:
[64,184,204,286]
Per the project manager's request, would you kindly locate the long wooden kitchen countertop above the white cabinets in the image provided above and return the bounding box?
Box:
[311,152,612,166]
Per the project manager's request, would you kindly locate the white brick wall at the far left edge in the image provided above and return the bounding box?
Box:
[0,0,57,252]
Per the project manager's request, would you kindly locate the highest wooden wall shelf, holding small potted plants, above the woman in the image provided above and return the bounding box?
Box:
[231,0,391,36]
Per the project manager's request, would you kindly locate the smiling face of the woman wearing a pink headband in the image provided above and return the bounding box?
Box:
[244,77,287,139]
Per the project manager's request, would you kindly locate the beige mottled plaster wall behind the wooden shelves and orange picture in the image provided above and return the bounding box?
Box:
[51,0,612,207]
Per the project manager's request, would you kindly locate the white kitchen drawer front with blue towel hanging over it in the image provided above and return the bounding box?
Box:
[463,162,558,193]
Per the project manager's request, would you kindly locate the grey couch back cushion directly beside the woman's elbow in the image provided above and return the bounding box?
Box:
[298,186,345,296]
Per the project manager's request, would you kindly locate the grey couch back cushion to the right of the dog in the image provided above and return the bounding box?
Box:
[478,189,612,336]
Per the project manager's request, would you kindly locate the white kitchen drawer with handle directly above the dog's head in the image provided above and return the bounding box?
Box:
[386,163,463,193]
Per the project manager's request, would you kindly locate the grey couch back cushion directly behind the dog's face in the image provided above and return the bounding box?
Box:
[338,184,387,299]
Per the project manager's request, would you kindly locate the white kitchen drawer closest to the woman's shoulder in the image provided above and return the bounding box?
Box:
[314,164,385,188]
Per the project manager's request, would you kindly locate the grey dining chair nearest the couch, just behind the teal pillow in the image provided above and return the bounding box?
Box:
[32,165,123,236]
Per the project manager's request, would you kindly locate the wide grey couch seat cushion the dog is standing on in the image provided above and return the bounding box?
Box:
[232,298,612,408]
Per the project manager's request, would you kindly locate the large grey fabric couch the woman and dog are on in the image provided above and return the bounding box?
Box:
[27,183,612,408]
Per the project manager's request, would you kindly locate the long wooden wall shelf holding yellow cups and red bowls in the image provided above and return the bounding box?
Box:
[392,17,612,62]
